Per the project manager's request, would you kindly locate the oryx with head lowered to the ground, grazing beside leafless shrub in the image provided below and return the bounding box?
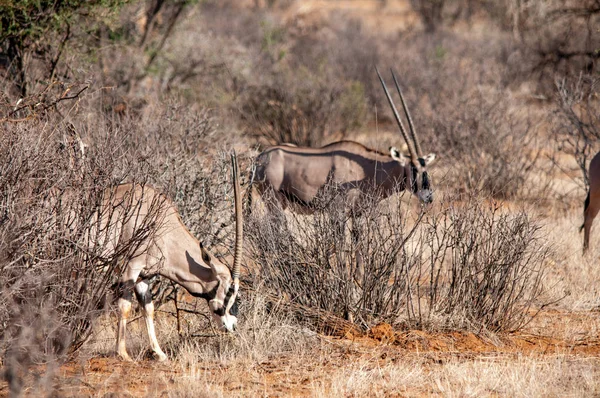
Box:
[110,153,243,361]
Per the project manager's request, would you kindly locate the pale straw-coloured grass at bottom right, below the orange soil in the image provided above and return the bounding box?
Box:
[312,356,600,397]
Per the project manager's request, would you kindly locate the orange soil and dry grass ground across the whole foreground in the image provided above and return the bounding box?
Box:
[0,310,600,397]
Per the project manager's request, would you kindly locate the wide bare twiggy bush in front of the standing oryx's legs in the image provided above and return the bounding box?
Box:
[247,189,549,332]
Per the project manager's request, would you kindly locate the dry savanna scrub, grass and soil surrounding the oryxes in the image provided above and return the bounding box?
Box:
[0,0,600,396]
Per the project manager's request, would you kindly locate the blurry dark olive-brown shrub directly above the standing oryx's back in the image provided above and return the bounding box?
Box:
[240,69,366,147]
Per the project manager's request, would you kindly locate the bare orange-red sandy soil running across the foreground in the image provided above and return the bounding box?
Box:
[0,311,600,397]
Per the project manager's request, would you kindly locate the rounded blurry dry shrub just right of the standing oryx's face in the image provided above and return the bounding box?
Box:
[434,92,543,199]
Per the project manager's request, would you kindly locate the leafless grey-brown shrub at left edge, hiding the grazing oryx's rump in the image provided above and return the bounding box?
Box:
[0,116,163,393]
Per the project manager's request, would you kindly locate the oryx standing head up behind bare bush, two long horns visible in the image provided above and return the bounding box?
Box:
[249,68,435,213]
